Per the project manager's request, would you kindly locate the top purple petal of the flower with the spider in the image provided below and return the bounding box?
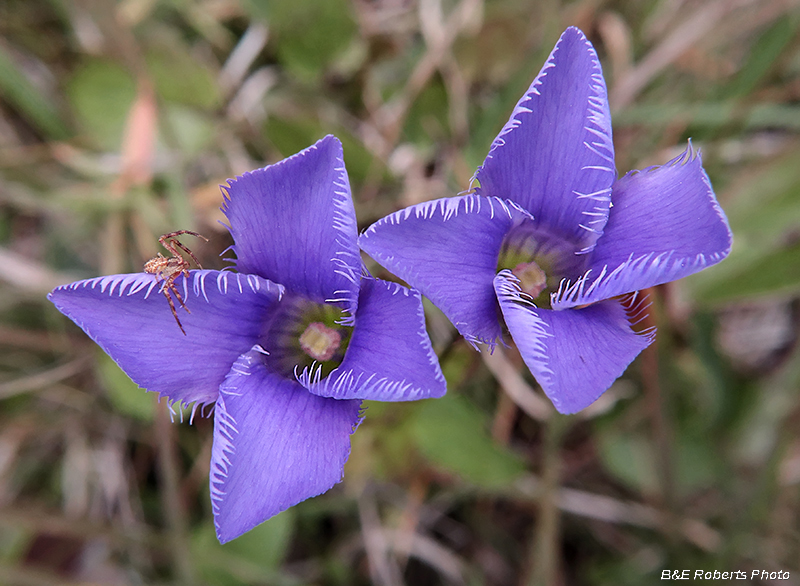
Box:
[222,135,361,316]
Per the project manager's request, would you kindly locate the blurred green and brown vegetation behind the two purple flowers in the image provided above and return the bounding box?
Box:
[0,0,800,586]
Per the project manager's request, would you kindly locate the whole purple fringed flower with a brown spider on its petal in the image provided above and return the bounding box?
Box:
[49,136,445,543]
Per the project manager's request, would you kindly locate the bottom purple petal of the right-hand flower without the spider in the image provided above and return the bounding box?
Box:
[495,271,655,413]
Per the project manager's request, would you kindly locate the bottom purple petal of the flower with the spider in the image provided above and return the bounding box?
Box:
[210,349,361,543]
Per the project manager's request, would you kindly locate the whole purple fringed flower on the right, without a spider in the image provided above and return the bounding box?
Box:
[359,28,732,413]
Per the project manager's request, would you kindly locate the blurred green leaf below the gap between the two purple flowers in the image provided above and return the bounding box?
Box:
[412,394,525,489]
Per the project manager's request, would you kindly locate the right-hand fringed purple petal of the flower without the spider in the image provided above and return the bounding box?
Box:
[553,144,733,308]
